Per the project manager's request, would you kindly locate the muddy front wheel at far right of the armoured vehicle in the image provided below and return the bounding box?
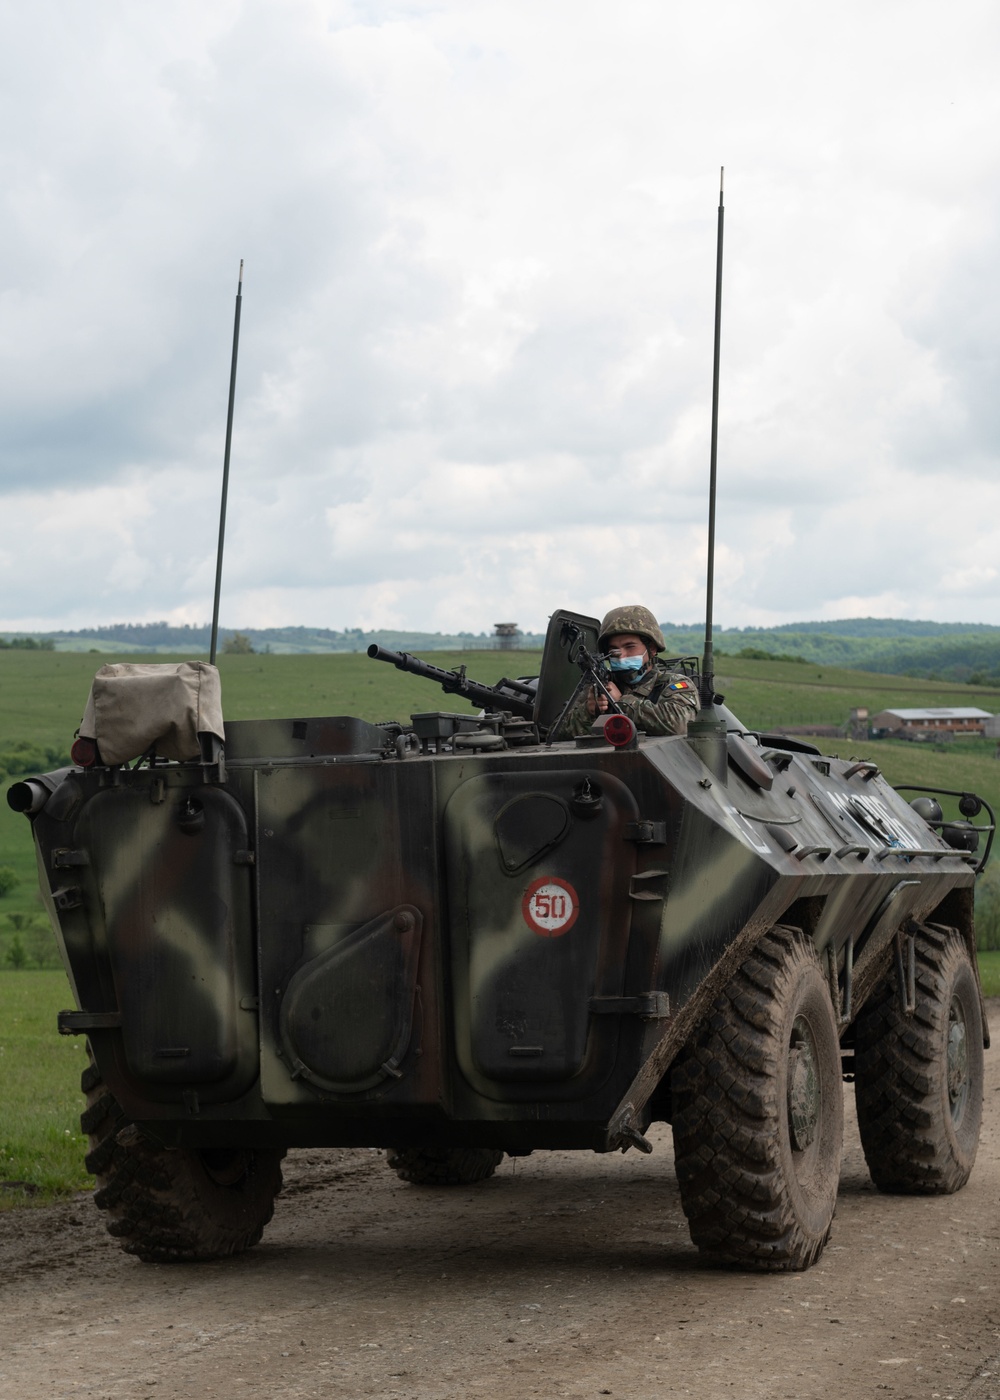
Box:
[854,927,983,1196]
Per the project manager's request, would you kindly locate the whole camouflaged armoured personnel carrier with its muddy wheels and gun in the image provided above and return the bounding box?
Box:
[8,612,993,1270]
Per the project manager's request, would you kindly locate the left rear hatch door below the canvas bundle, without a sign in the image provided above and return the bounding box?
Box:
[74,787,256,1098]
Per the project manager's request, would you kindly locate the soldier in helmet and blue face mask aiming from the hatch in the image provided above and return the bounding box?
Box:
[555,603,699,739]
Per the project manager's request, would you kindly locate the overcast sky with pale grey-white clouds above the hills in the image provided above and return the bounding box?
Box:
[0,0,1000,631]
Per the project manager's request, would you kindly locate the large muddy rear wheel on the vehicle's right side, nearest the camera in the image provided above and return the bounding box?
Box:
[671,927,843,1271]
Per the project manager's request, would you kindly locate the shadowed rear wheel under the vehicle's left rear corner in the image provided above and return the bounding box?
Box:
[80,1064,284,1264]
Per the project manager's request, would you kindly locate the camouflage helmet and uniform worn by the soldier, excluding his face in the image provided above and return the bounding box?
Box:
[553,603,699,739]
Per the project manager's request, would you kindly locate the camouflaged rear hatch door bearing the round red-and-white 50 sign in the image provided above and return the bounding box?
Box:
[444,770,639,1092]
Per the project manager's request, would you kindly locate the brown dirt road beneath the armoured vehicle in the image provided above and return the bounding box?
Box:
[0,1001,1000,1400]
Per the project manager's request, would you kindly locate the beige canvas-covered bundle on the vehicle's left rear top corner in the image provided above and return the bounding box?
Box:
[80,661,225,763]
